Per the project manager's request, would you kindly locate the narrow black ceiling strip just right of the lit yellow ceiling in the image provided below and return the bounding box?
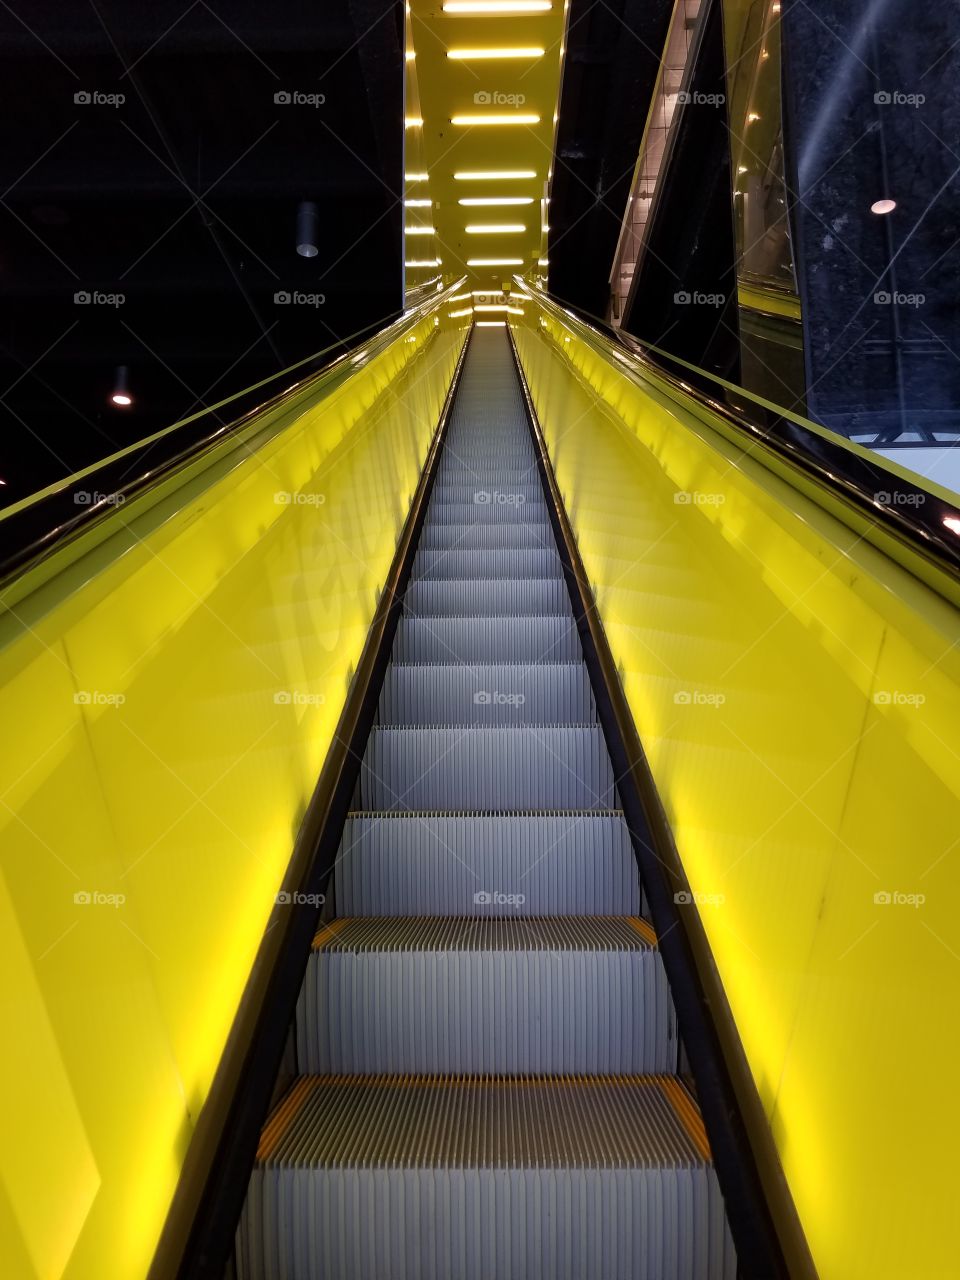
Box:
[549,0,672,316]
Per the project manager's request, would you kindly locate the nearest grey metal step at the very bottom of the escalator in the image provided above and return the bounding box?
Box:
[237,1075,736,1280]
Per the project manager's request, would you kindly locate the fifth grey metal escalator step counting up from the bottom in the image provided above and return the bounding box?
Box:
[378,665,596,726]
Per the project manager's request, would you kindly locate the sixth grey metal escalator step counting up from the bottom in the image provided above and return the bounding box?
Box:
[393,617,582,663]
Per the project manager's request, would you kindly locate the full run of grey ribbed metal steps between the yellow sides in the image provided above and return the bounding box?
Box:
[236,328,737,1280]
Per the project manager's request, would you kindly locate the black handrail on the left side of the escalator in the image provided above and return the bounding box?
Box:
[0,282,460,589]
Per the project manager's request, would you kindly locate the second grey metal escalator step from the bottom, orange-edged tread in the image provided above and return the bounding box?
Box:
[297,916,677,1075]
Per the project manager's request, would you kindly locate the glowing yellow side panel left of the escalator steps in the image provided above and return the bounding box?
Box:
[0,291,465,1280]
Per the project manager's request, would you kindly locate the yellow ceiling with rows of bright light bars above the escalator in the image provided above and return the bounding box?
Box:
[404,0,567,292]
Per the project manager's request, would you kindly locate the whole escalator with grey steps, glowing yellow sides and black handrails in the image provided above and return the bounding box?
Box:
[0,282,960,1280]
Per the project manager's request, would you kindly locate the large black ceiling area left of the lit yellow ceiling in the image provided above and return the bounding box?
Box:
[0,0,403,503]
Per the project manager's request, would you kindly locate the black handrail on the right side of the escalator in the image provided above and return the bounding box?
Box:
[517,278,960,603]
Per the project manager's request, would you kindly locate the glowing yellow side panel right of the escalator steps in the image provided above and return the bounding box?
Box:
[512,302,960,1280]
